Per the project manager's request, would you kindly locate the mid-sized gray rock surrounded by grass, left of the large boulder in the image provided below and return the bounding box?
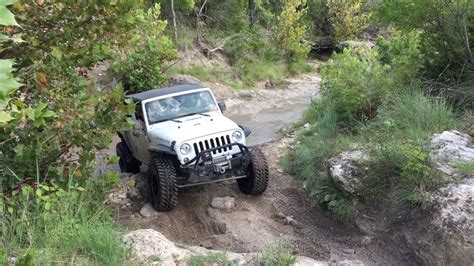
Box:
[329,150,369,194]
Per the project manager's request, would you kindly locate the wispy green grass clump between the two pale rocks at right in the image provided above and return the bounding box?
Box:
[360,89,458,204]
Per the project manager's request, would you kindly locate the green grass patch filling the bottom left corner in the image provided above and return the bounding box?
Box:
[0,169,128,265]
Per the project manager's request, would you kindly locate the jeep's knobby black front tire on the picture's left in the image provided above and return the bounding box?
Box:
[148,156,178,211]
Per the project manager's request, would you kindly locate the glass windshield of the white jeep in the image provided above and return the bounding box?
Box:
[145,91,218,125]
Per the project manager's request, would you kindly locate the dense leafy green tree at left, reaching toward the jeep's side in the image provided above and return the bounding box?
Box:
[0,0,180,190]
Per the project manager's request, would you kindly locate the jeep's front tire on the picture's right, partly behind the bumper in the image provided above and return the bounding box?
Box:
[237,147,268,195]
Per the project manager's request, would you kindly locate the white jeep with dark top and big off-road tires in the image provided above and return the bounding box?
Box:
[117,84,268,211]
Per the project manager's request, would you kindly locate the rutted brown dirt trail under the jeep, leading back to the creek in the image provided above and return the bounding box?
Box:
[110,68,413,265]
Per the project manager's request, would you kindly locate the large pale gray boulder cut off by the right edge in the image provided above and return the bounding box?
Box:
[402,130,474,265]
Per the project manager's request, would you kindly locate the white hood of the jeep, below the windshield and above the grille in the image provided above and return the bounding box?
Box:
[148,114,240,145]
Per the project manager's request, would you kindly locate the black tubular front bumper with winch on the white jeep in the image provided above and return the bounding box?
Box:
[181,143,252,183]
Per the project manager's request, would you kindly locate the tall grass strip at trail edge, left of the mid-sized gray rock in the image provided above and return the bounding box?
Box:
[281,100,354,220]
